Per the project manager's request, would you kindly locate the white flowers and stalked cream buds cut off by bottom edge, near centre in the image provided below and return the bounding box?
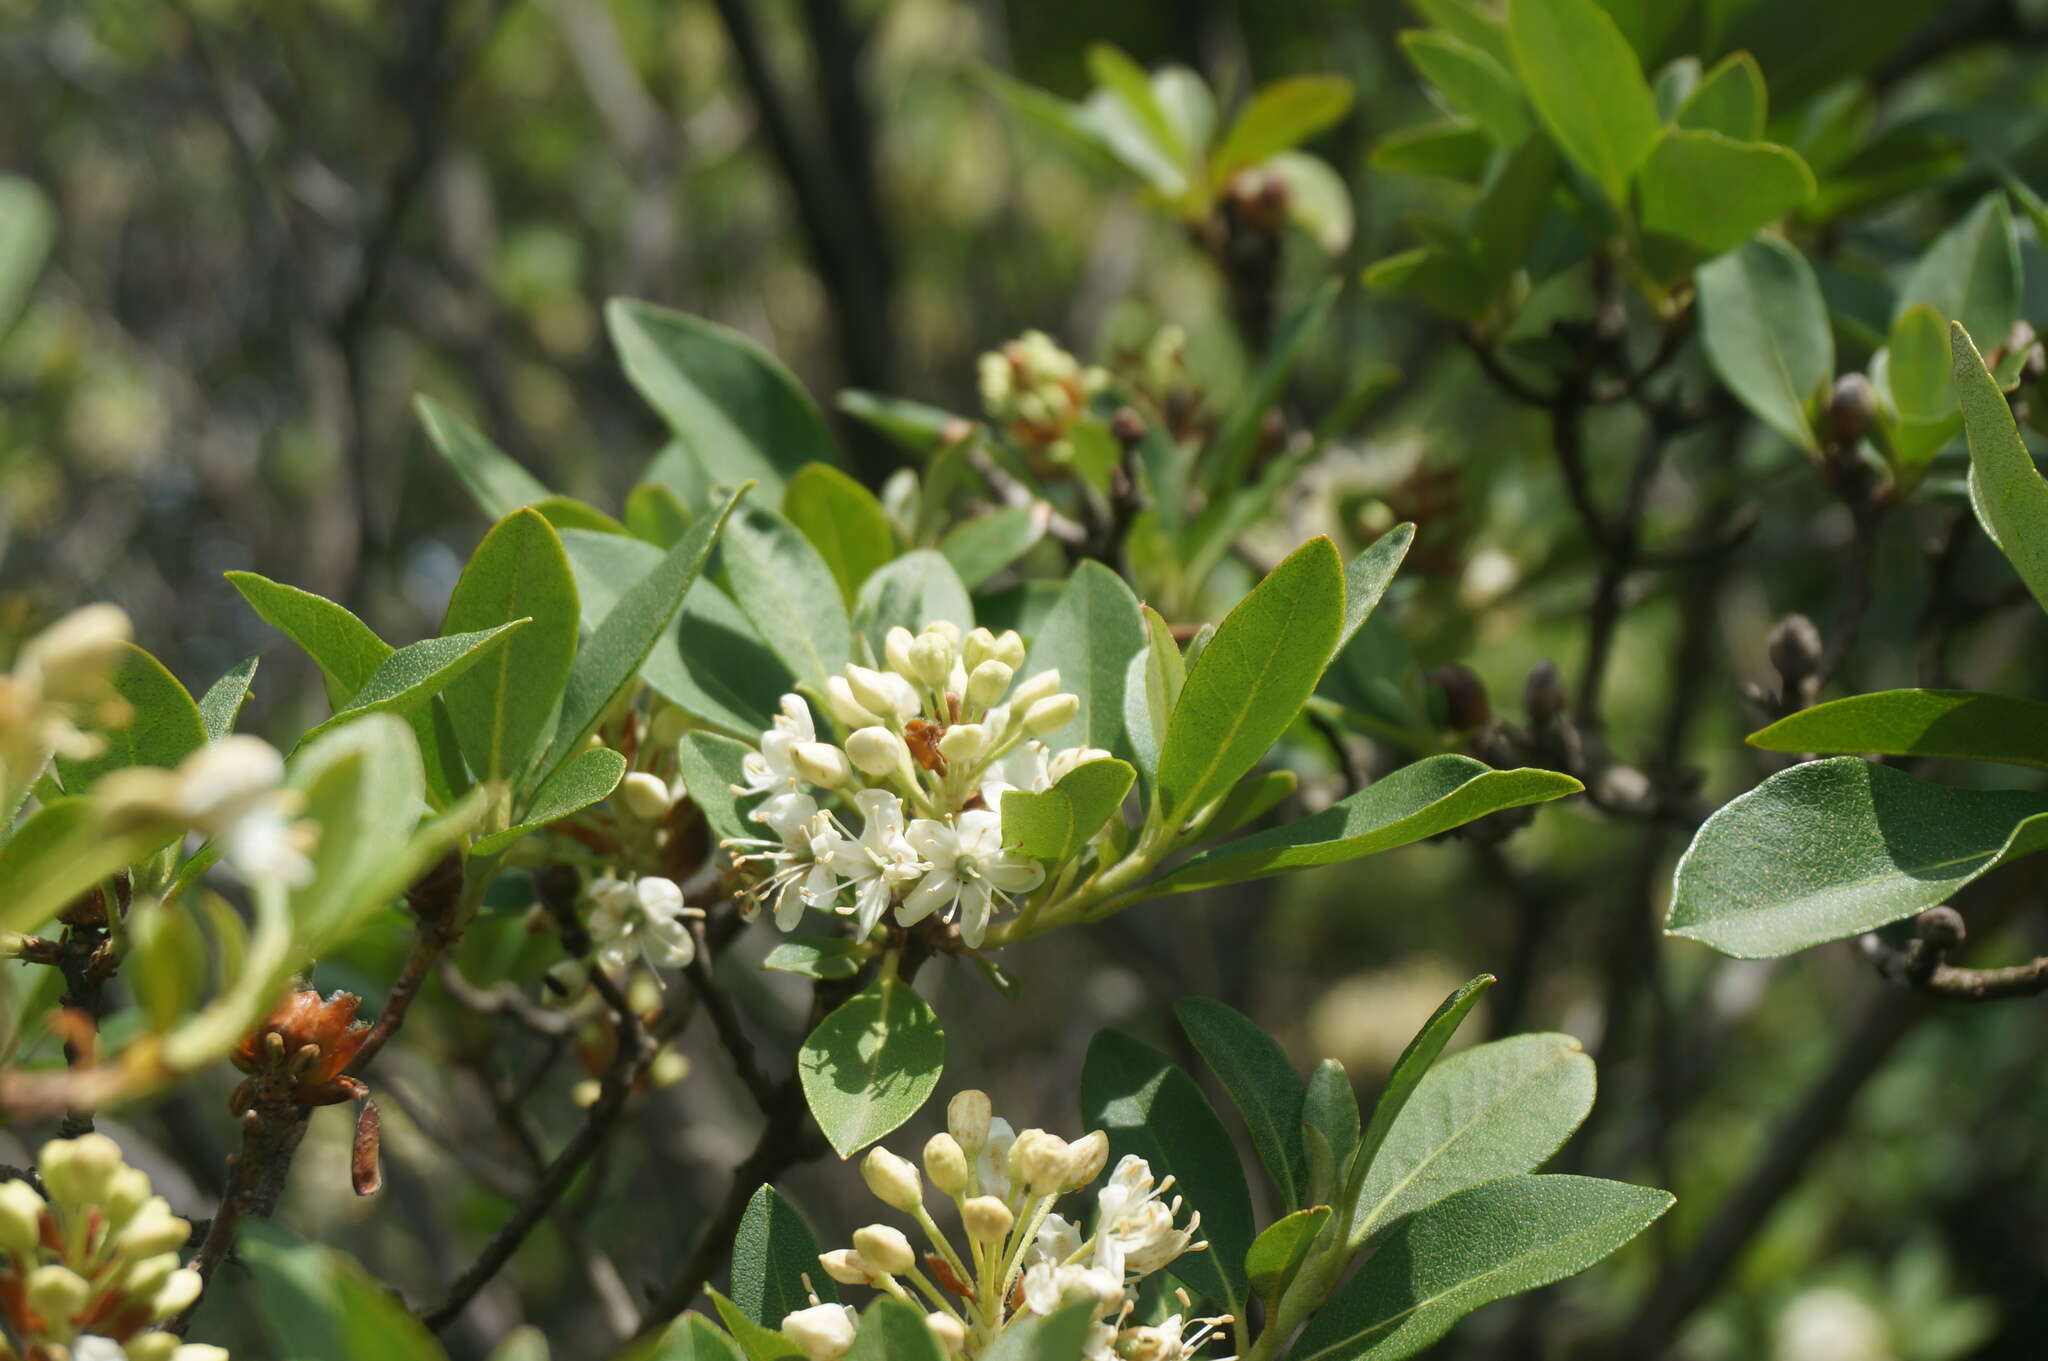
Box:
[782,1091,1231,1361]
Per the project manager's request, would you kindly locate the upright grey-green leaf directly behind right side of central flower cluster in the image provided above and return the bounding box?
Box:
[1018,563,1145,751]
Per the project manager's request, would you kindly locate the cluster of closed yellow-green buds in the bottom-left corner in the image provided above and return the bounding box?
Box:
[0,1134,227,1361]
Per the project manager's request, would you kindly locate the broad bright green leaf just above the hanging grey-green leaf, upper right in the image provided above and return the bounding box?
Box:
[1640,127,1815,256]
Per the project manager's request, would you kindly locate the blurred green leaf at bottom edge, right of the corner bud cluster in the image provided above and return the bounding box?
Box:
[236,1220,449,1361]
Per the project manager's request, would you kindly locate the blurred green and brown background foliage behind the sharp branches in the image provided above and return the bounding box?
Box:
[0,0,2048,1361]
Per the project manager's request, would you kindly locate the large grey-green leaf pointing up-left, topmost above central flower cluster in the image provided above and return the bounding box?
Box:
[604,299,840,491]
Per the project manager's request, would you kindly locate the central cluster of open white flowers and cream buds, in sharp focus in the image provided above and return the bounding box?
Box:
[727,620,1108,948]
